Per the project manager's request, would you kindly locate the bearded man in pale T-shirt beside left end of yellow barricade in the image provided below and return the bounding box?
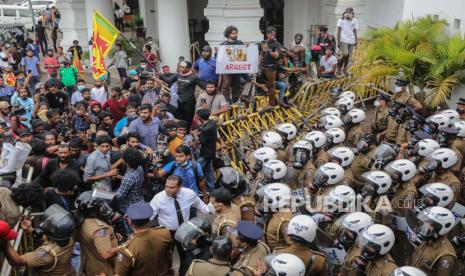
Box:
[195,80,228,116]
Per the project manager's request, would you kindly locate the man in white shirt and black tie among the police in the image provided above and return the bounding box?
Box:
[150,175,210,231]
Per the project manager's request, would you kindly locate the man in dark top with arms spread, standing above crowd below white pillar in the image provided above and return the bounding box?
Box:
[160,61,204,125]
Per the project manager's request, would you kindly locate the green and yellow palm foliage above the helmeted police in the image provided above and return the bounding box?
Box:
[354,15,465,107]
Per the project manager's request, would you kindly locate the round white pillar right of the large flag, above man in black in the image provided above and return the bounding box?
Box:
[158,0,190,69]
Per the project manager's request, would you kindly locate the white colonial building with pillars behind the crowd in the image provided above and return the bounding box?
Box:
[57,0,465,69]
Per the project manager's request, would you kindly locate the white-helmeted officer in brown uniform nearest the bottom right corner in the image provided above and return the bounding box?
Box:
[412,207,457,275]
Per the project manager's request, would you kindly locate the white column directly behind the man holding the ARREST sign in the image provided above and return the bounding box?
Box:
[204,0,263,46]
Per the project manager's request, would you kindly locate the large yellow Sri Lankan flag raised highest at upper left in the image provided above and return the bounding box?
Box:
[92,10,119,80]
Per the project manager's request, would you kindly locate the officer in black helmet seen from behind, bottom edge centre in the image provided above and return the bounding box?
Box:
[186,236,244,276]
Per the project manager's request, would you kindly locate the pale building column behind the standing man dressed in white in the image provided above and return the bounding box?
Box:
[321,0,368,36]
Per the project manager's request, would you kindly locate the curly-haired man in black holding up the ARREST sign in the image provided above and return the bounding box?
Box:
[219,26,244,103]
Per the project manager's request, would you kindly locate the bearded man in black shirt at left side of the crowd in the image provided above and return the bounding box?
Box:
[34,144,80,188]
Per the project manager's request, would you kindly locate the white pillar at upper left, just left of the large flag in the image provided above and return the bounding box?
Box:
[57,0,87,48]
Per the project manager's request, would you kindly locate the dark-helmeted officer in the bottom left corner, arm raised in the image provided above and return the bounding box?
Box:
[1,204,75,276]
